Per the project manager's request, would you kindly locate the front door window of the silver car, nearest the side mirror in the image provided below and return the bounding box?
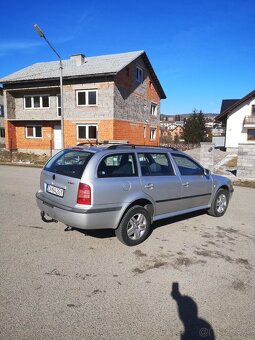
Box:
[172,154,204,176]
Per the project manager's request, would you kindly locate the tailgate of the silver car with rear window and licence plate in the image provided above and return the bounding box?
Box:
[40,149,93,207]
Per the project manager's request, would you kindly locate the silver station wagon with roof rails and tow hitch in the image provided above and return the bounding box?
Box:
[36,144,233,246]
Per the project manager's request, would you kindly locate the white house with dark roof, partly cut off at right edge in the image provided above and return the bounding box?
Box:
[215,90,255,149]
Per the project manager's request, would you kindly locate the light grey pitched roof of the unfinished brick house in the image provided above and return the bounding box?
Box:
[0,51,166,98]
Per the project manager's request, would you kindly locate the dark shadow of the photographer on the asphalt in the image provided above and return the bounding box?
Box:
[171,282,215,340]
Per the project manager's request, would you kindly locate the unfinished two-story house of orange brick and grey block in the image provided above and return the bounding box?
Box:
[0,51,166,152]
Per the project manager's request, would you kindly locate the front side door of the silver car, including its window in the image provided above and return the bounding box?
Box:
[171,153,212,210]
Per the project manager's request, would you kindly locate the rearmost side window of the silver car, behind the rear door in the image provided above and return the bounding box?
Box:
[97,153,137,178]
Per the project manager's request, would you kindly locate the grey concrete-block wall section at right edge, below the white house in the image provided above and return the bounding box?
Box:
[237,143,255,179]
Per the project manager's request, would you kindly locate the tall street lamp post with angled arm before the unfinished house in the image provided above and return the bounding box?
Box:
[34,24,65,149]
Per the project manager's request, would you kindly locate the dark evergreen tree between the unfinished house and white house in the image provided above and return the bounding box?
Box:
[182,109,206,143]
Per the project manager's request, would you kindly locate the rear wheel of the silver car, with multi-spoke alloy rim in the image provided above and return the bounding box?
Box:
[115,205,151,247]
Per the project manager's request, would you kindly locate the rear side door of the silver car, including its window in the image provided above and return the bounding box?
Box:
[138,152,181,215]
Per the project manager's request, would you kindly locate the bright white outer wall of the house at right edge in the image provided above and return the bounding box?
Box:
[225,99,255,148]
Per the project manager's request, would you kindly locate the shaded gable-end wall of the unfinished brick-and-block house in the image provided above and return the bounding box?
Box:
[114,58,160,144]
